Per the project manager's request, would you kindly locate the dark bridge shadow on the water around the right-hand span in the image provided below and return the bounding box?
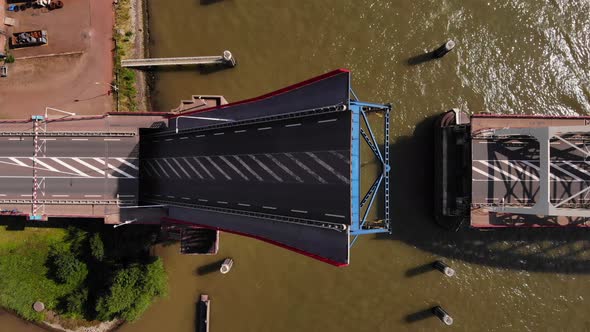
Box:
[376,117,590,276]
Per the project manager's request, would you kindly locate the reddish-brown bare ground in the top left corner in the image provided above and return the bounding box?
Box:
[0,0,114,118]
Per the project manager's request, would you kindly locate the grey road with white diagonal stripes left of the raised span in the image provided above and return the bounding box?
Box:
[0,136,139,200]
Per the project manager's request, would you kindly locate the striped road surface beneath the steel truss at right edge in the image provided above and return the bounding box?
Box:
[472,139,590,205]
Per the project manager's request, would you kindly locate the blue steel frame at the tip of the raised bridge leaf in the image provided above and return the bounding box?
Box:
[349,89,391,247]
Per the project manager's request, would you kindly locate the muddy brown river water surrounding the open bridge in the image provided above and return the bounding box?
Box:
[0,0,590,332]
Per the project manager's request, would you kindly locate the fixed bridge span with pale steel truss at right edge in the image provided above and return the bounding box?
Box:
[471,117,590,227]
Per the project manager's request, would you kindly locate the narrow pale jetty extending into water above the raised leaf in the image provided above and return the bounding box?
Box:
[121,51,236,68]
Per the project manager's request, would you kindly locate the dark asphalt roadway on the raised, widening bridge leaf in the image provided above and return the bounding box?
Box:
[141,112,350,224]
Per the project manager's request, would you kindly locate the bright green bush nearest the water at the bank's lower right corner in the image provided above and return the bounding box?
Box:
[96,258,166,321]
